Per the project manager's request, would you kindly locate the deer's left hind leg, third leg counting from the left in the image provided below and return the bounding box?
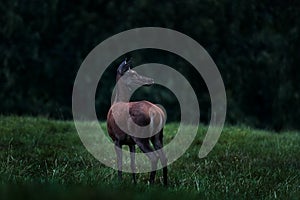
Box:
[134,138,158,184]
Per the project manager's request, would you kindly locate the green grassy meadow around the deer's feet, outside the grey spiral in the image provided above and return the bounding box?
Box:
[0,116,300,199]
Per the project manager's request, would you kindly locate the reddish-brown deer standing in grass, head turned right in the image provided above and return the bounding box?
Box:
[107,58,168,186]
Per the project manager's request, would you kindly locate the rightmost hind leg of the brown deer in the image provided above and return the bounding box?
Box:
[151,131,168,186]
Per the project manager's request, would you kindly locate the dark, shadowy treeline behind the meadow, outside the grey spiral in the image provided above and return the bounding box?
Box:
[0,0,300,130]
